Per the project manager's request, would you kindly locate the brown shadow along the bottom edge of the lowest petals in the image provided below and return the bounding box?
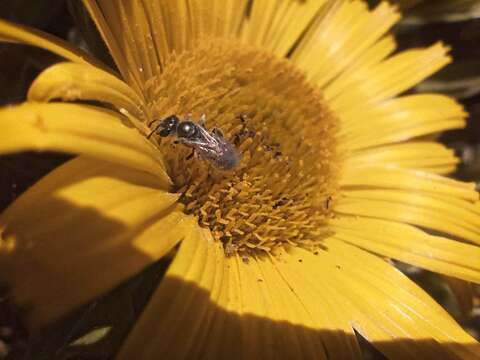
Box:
[117,277,480,359]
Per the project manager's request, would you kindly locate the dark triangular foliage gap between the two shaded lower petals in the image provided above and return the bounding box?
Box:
[9,261,168,360]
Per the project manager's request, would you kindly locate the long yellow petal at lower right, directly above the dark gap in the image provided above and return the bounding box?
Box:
[329,217,480,283]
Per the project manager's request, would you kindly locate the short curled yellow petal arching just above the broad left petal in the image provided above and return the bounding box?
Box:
[28,63,145,118]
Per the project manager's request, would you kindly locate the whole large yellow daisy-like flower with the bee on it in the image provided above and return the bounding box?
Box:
[0,0,480,359]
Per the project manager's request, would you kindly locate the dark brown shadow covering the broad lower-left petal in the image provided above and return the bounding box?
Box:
[0,198,183,329]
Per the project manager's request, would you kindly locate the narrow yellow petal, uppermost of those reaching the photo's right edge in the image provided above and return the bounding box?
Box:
[340,163,478,202]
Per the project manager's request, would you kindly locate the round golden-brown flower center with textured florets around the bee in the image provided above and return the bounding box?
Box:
[146,40,339,255]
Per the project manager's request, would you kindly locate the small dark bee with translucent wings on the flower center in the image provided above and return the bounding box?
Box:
[147,115,240,170]
